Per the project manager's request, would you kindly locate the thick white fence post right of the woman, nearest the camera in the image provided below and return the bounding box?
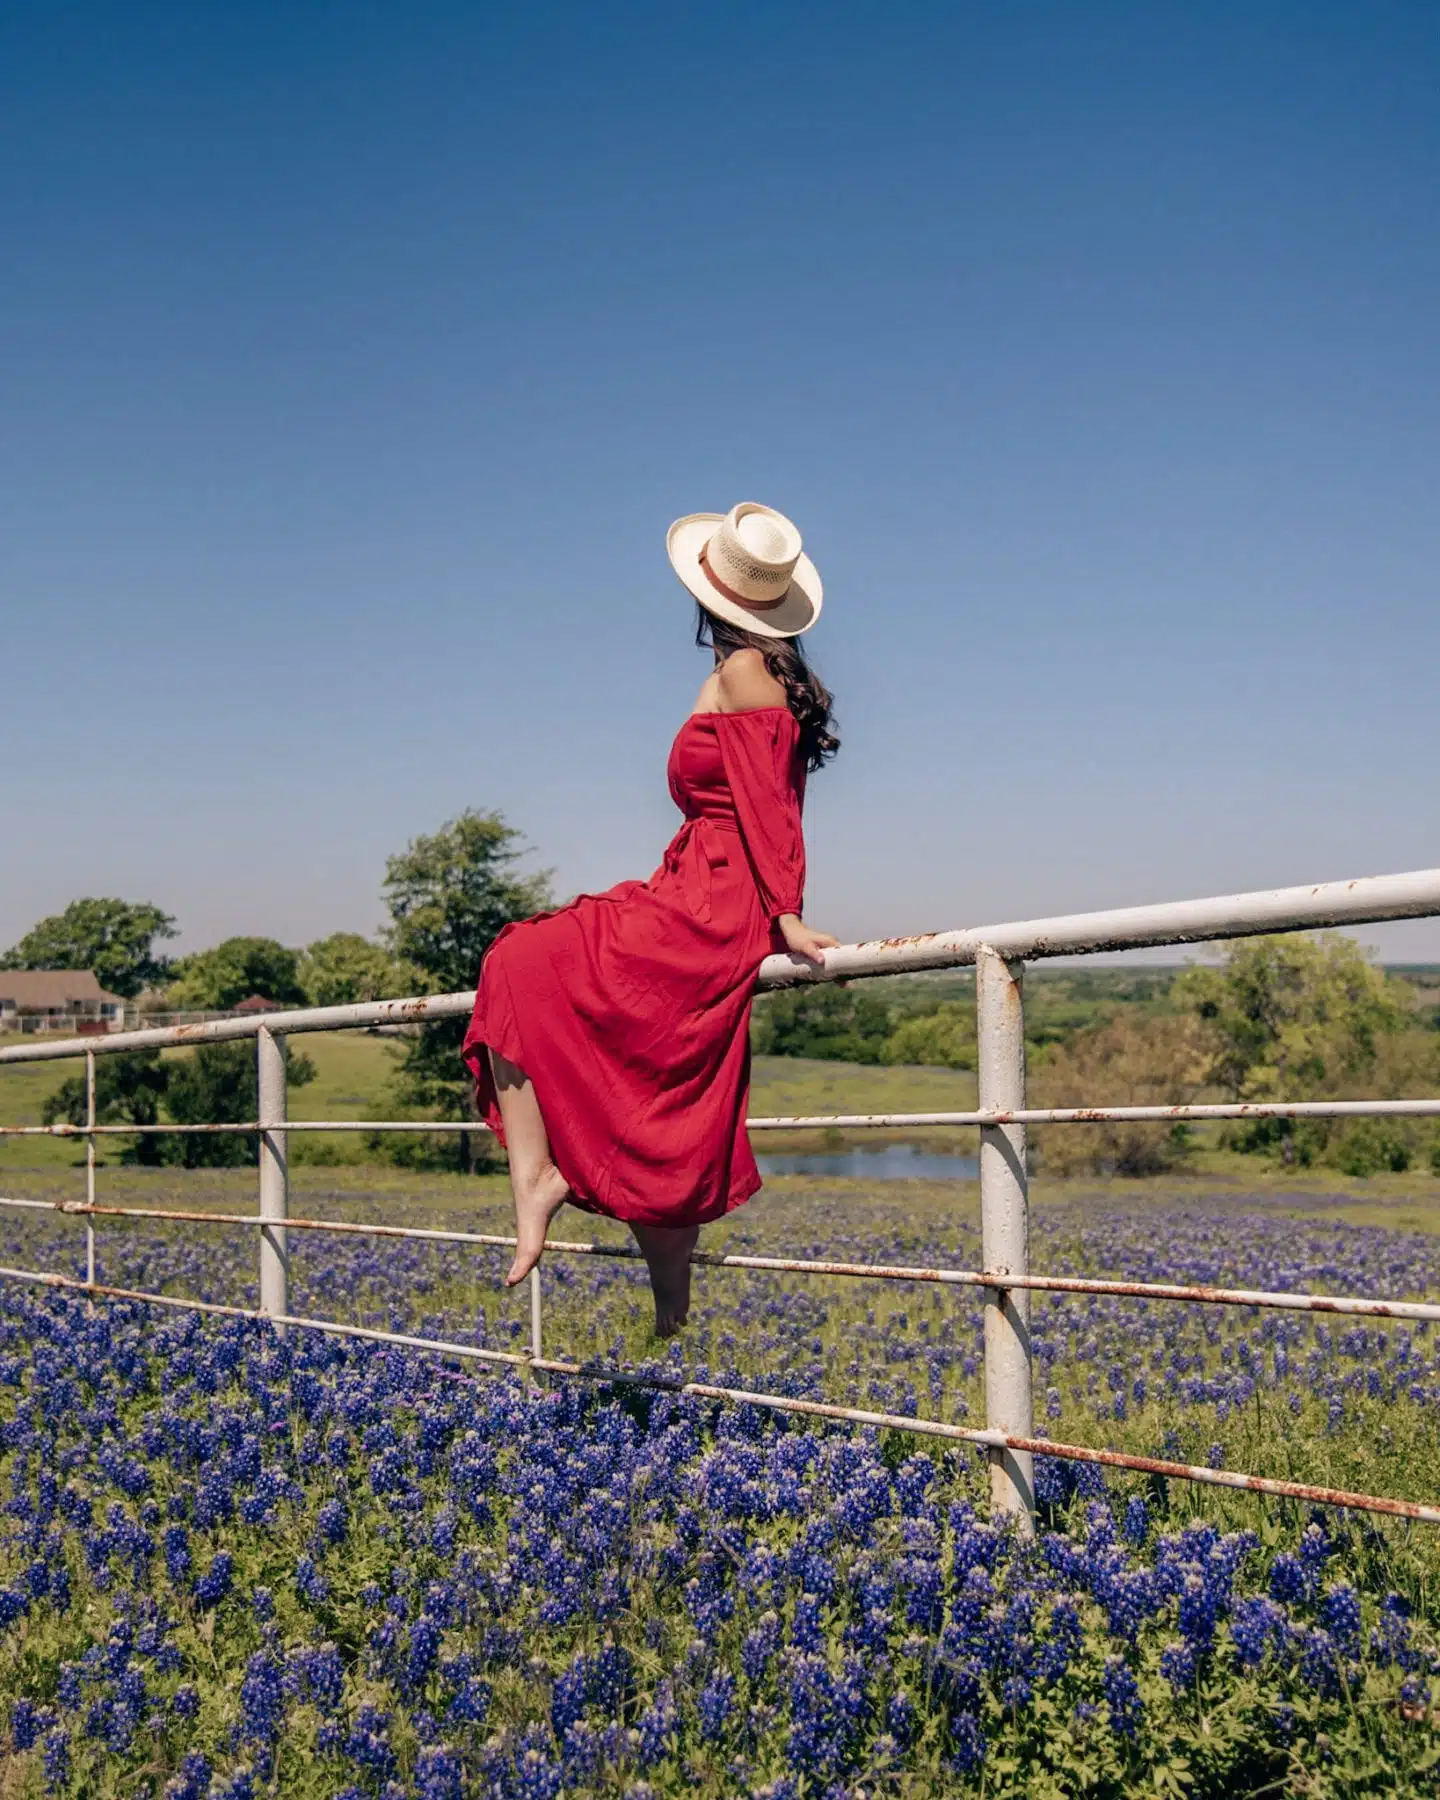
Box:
[976,947,1035,1532]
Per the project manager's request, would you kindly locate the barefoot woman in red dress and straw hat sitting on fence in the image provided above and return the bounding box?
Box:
[464,504,839,1336]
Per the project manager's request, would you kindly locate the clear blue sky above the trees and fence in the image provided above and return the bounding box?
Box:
[0,0,1440,959]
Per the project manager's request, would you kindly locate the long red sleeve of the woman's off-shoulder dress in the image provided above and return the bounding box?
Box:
[713,707,805,920]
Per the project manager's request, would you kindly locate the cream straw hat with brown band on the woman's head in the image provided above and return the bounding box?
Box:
[666,500,824,637]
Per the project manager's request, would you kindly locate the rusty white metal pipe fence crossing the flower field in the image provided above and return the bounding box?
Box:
[0,869,1440,1528]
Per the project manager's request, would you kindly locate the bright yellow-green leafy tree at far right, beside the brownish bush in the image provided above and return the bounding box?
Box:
[1174,931,1413,1163]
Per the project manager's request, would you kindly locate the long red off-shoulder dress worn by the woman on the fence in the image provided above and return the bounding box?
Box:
[464,706,805,1226]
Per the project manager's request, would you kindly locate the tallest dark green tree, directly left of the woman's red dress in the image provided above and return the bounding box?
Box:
[382,808,551,1170]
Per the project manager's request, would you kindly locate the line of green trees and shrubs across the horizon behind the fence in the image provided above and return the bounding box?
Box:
[0,828,1440,1175]
